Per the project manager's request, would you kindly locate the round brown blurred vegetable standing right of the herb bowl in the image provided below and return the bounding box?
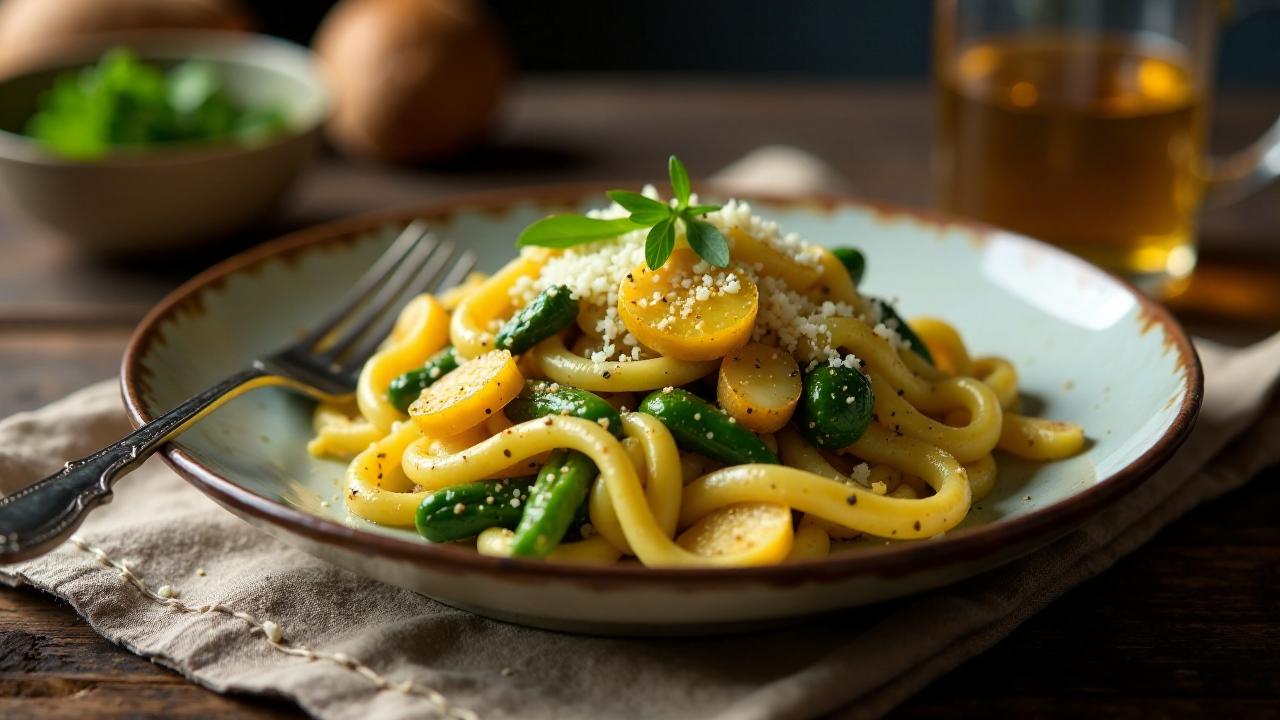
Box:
[314,0,508,163]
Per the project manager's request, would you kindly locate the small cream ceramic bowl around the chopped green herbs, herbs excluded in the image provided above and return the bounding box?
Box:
[0,31,330,255]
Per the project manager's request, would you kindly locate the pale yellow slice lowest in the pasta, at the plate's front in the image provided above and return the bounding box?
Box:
[676,502,794,565]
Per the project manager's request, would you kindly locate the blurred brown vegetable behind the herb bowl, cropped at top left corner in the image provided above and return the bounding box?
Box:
[0,0,253,73]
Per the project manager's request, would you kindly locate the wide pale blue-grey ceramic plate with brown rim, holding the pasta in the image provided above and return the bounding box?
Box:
[123,187,1201,634]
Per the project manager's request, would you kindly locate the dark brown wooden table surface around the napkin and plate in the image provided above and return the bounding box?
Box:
[0,78,1280,719]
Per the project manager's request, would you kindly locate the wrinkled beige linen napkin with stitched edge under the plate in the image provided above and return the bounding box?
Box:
[0,150,1280,720]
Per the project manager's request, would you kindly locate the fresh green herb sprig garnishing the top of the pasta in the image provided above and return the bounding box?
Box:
[516,155,728,270]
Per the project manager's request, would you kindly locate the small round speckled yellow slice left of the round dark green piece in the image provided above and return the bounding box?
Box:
[716,342,801,433]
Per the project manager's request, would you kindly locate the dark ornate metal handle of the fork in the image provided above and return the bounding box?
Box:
[0,365,273,564]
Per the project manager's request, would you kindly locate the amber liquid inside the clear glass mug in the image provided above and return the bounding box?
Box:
[934,36,1204,292]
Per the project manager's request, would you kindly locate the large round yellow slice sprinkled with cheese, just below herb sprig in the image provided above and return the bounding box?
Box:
[618,250,759,360]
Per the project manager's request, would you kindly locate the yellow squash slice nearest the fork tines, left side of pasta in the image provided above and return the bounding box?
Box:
[408,350,525,437]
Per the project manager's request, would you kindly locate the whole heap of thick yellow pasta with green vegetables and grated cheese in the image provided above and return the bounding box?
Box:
[308,192,1084,568]
